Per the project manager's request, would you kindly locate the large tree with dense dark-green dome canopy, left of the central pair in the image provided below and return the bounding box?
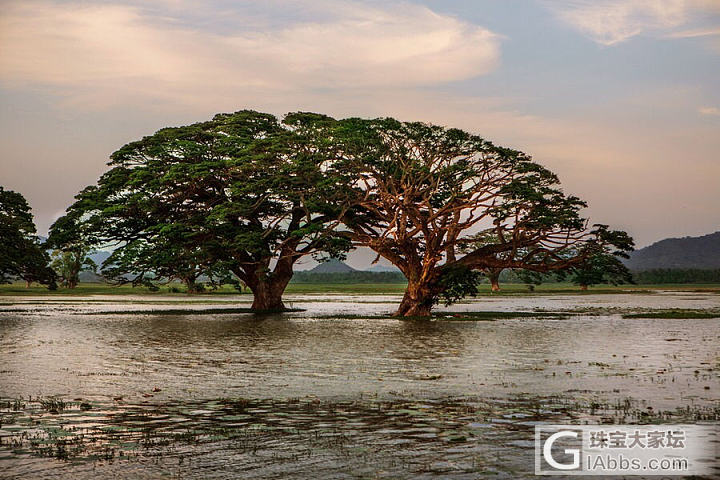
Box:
[52,110,350,310]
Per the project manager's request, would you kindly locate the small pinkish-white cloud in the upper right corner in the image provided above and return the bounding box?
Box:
[543,0,720,45]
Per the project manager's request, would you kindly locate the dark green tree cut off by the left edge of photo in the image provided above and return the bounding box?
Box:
[0,187,55,289]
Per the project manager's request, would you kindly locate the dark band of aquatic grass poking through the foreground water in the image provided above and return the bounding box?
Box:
[0,392,720,473]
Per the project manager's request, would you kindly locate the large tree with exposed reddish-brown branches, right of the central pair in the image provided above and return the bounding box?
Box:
[296,118,632,316]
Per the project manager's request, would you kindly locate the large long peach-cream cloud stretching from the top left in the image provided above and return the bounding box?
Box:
[0,0,500,109]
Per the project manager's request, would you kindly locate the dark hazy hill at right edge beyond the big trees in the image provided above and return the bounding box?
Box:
[625,232,720,271]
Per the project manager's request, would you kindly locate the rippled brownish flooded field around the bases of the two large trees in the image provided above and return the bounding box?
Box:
[0,292,720,479]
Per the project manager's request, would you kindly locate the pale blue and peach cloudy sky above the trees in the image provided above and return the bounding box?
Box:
[0,0,720,266]
